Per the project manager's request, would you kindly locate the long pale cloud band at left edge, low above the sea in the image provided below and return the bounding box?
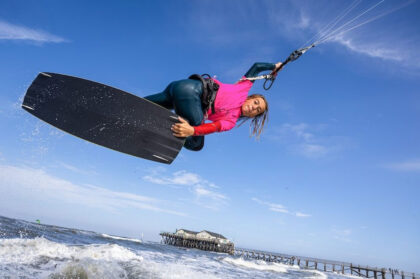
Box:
[0,165,185,216]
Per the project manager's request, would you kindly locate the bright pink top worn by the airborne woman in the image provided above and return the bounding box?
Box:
[207,79,253,132]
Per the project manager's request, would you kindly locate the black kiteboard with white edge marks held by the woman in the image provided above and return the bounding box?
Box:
[22,73,185,164]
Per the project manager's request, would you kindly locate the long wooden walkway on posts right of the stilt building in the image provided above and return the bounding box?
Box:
[234,248,420,279]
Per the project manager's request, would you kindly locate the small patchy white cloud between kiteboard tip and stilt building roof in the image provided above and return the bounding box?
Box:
[143,169,229,210]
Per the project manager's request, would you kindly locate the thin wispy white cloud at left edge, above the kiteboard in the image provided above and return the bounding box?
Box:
[0,21,67,43]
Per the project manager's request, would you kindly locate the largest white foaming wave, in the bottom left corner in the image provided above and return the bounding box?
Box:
[0,237,143,279]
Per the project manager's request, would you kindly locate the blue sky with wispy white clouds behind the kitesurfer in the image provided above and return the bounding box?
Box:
[0,0,420,273]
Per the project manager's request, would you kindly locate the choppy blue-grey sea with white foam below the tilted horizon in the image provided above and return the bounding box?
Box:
[0,216,355,279]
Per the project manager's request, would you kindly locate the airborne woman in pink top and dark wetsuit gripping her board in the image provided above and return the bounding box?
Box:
[145,62,282,151]
